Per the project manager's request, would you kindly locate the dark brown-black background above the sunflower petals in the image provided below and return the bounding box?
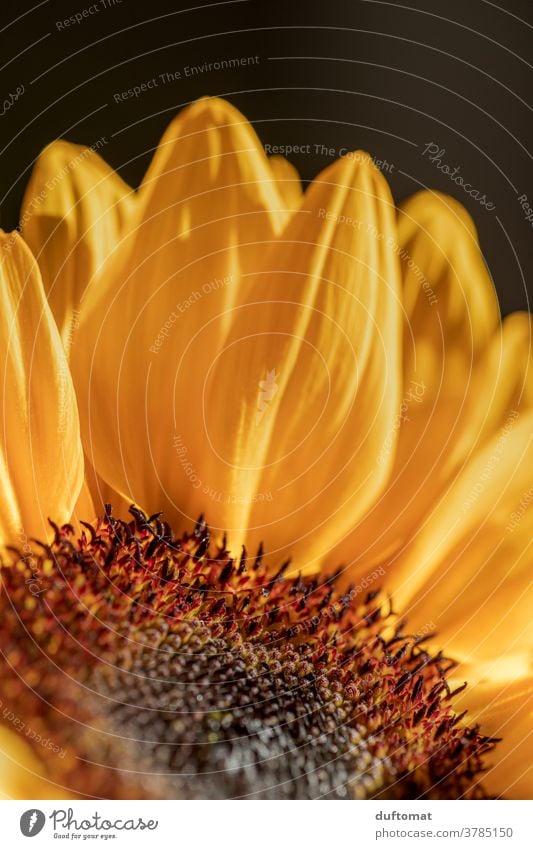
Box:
[0,0,533,313]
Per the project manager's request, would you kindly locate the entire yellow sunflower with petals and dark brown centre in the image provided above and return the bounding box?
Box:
[0,98,533,798]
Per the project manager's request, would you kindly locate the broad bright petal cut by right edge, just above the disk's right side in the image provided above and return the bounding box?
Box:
[387,411,533,648]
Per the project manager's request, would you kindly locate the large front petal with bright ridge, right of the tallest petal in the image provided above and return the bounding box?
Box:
[194,153,400,571]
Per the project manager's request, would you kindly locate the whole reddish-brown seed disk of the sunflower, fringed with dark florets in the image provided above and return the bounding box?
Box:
[0,507,496,799]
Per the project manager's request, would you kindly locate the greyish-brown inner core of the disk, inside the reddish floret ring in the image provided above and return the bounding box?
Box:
[89,630,384,799]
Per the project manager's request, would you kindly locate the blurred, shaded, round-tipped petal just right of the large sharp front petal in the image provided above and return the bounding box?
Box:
[332,192,502,573]
